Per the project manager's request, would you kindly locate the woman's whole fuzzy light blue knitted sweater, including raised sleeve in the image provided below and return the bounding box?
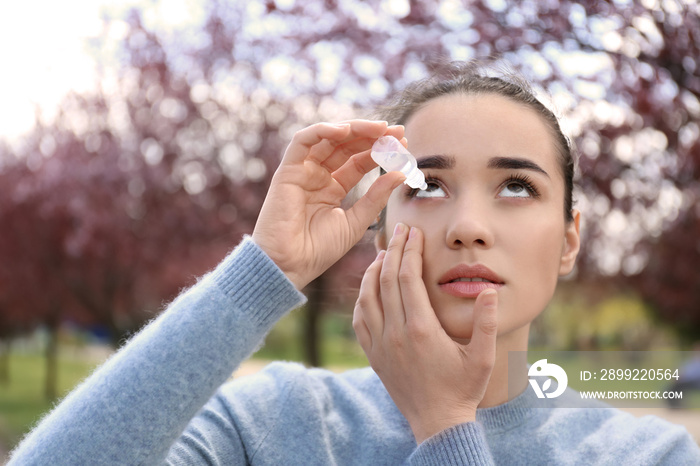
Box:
[9,239,700,466]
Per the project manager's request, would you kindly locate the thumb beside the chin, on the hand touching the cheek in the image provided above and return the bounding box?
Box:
[468,290,498,375]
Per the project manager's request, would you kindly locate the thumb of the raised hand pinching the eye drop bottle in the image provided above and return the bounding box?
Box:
[347,172,406,238]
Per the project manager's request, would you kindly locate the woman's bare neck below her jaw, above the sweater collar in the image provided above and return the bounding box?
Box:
[479,324,530,408]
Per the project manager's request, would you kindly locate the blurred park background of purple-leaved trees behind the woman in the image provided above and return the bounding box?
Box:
[0,0,700,459]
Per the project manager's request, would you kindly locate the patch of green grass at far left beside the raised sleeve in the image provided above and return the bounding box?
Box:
[0,353,101,449]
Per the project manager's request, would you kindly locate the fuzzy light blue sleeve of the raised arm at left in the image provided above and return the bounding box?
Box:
[8,238,305,465]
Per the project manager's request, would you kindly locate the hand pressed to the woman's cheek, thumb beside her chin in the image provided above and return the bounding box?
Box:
[353,224,498,443]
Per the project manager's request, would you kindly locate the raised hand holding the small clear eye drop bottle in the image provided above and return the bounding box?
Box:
[253,120,405,290]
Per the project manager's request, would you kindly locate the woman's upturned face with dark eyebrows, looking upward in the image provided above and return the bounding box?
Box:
[378,94,579,339]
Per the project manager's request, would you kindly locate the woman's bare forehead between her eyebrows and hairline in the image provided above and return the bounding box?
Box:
[405,94,558,170]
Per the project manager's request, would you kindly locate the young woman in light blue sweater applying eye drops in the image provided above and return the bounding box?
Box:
[10,65,700,465]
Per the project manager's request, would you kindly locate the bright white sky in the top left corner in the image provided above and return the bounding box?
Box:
[0,0,206,141]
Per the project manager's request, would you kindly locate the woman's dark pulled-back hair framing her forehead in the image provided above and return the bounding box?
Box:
[374,61,575,235]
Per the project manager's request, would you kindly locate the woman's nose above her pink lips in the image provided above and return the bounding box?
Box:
[445,199,494,249]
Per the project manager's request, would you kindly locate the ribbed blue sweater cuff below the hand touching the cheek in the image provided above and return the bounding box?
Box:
[408,422,495,466]
